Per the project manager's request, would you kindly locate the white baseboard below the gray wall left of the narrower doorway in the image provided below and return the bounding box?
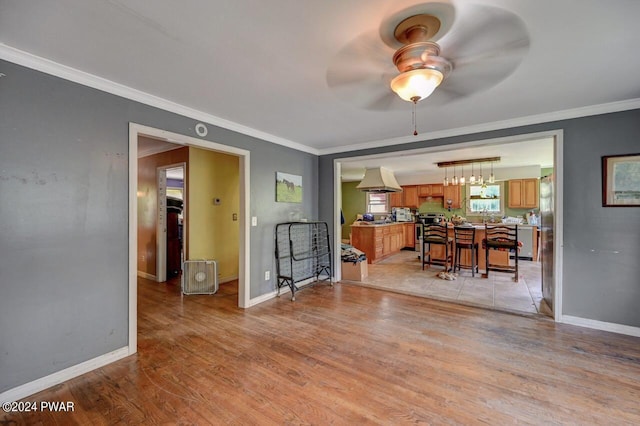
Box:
[0,346,129,403]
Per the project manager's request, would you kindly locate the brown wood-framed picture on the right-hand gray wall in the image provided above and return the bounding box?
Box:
[602,154,640,207]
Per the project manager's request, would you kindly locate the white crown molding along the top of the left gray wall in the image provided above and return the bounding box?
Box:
[0,43,319,155]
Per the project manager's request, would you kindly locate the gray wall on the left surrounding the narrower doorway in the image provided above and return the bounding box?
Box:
[0,61,318,392]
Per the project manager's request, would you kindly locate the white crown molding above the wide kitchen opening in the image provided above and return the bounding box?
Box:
[319,98,640,155]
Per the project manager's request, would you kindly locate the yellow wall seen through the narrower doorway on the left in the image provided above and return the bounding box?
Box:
[187,147,240,282]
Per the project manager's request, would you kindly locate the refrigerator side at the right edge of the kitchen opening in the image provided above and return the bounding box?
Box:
[540,173,555,312]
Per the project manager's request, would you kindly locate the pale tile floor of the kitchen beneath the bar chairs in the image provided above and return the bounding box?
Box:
[342,251,551,316]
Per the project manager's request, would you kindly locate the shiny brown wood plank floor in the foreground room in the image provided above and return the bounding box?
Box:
[5,279,640,425]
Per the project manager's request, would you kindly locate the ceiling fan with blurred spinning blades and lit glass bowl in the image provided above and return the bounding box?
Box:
[327,2,529,115]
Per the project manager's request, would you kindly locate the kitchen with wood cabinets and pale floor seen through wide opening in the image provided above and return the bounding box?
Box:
[342,139,553,315]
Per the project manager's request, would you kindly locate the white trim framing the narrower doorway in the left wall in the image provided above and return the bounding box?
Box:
[128,122,251,355]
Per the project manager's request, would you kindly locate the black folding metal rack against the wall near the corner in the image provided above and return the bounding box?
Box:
[275,222,333,301]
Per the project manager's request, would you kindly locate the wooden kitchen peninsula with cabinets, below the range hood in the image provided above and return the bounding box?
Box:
[351,222,404,263]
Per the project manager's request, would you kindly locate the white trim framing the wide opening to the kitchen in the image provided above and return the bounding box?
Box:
[334,130,562,321]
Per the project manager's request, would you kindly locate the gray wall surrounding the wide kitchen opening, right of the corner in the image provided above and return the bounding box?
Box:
[319,110,640,327]
